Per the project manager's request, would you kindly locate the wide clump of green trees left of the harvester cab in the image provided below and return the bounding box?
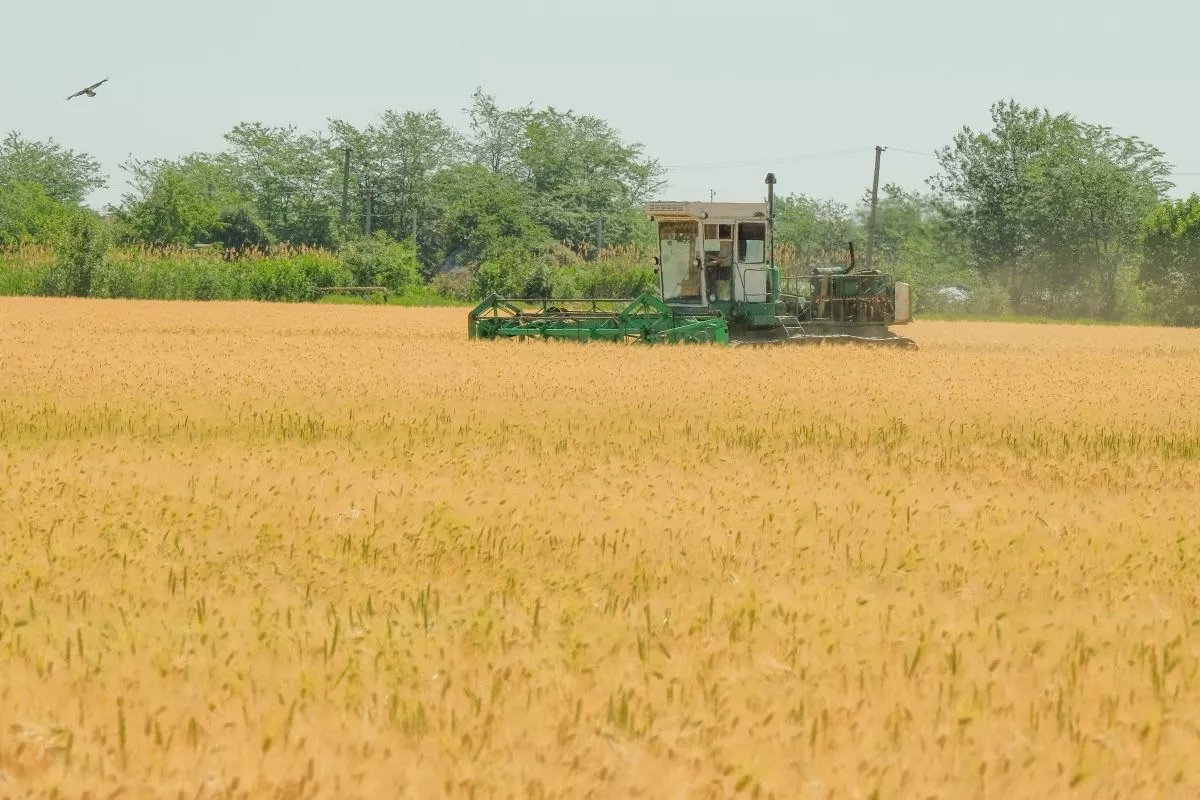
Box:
[105,90,662,293]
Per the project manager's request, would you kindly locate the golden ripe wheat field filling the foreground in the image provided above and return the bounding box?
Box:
[0,299,1200,800]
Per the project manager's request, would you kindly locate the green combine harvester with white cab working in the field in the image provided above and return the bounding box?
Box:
[468,175,916,348]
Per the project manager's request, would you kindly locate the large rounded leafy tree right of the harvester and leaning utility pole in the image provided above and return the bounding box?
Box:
[931,101,1170,317]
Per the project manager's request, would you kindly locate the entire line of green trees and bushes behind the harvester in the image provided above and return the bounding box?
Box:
[7,97,1200,325]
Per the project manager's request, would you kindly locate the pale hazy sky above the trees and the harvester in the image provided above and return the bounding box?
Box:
[9,0,1200,211]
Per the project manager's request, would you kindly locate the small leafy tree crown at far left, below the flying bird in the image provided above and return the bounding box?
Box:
[0,131,108,205]
